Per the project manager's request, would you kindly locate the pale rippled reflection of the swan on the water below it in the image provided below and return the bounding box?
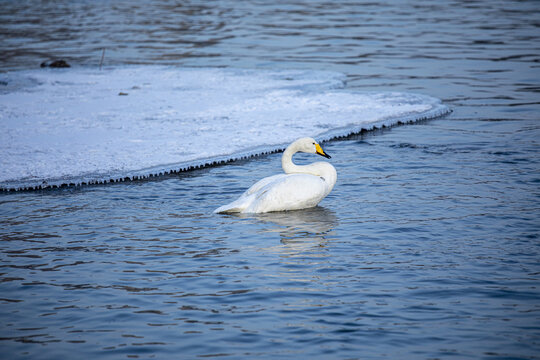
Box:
[233,206,338,252]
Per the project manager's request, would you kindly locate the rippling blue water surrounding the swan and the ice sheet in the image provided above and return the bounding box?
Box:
[0,1,540,359]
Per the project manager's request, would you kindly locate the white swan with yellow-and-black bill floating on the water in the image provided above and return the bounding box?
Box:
[214,137,337,213]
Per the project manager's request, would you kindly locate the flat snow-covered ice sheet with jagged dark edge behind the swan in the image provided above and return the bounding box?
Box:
[0,66,448,189]
